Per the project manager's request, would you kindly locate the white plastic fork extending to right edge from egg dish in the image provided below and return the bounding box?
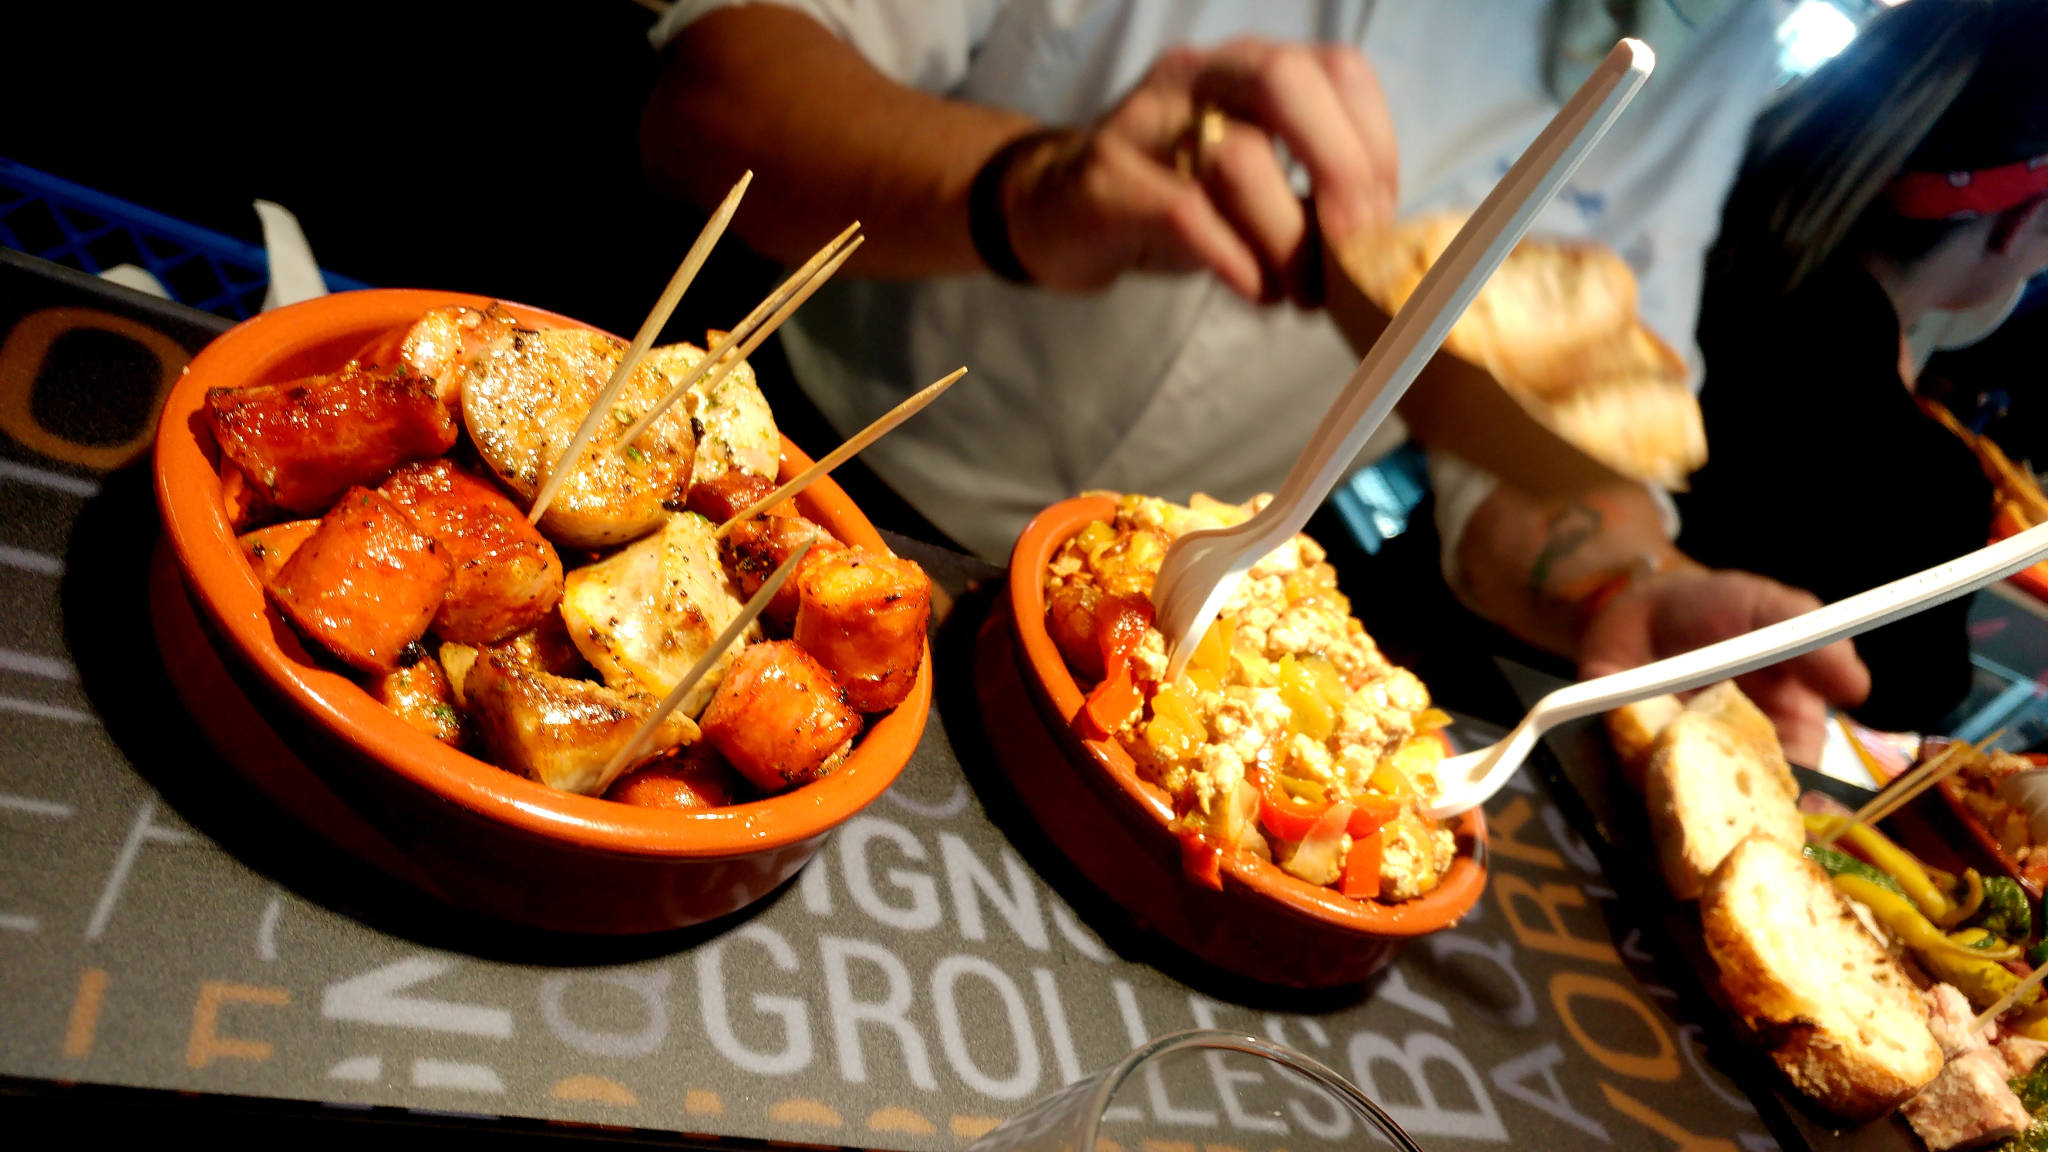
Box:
[1430,525,2048,818]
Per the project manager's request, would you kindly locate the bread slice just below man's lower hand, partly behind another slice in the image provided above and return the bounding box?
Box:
[1642,711,1806,900]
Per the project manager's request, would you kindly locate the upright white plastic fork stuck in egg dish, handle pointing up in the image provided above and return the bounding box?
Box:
[1153,39,1657,681]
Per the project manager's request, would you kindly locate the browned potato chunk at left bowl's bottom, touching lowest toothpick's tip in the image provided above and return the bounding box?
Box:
[465,654,698,795]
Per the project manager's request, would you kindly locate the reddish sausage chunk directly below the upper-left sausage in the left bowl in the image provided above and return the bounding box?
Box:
[266,488,453,674]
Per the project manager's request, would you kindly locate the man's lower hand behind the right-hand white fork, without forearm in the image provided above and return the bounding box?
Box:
[1579,568,1870,767]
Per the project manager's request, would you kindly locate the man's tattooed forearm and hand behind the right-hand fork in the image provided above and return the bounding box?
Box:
[1454,469,1870,765]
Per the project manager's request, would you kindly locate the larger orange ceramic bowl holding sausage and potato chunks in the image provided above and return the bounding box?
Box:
[156,289,932,933]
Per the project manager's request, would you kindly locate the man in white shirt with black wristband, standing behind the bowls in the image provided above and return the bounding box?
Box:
[641,0,1864,758]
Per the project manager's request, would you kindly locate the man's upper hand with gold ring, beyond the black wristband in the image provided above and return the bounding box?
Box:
[1004,39,1397,305]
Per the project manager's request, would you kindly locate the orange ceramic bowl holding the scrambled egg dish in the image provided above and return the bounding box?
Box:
[977,487,1487,988]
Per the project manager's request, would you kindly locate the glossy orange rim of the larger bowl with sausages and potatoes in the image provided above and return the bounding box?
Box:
[154,289,932,859]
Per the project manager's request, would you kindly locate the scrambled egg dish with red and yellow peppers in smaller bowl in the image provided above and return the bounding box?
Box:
[1047,494,1454,900]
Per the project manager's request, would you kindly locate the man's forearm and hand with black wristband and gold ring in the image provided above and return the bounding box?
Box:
[641,4,1395,301]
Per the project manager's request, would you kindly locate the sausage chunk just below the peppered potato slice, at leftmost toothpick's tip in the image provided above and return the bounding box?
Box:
[377,459,561,644]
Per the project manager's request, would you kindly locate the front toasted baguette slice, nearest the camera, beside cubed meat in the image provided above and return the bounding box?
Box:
[1700,836,1942,1121]
